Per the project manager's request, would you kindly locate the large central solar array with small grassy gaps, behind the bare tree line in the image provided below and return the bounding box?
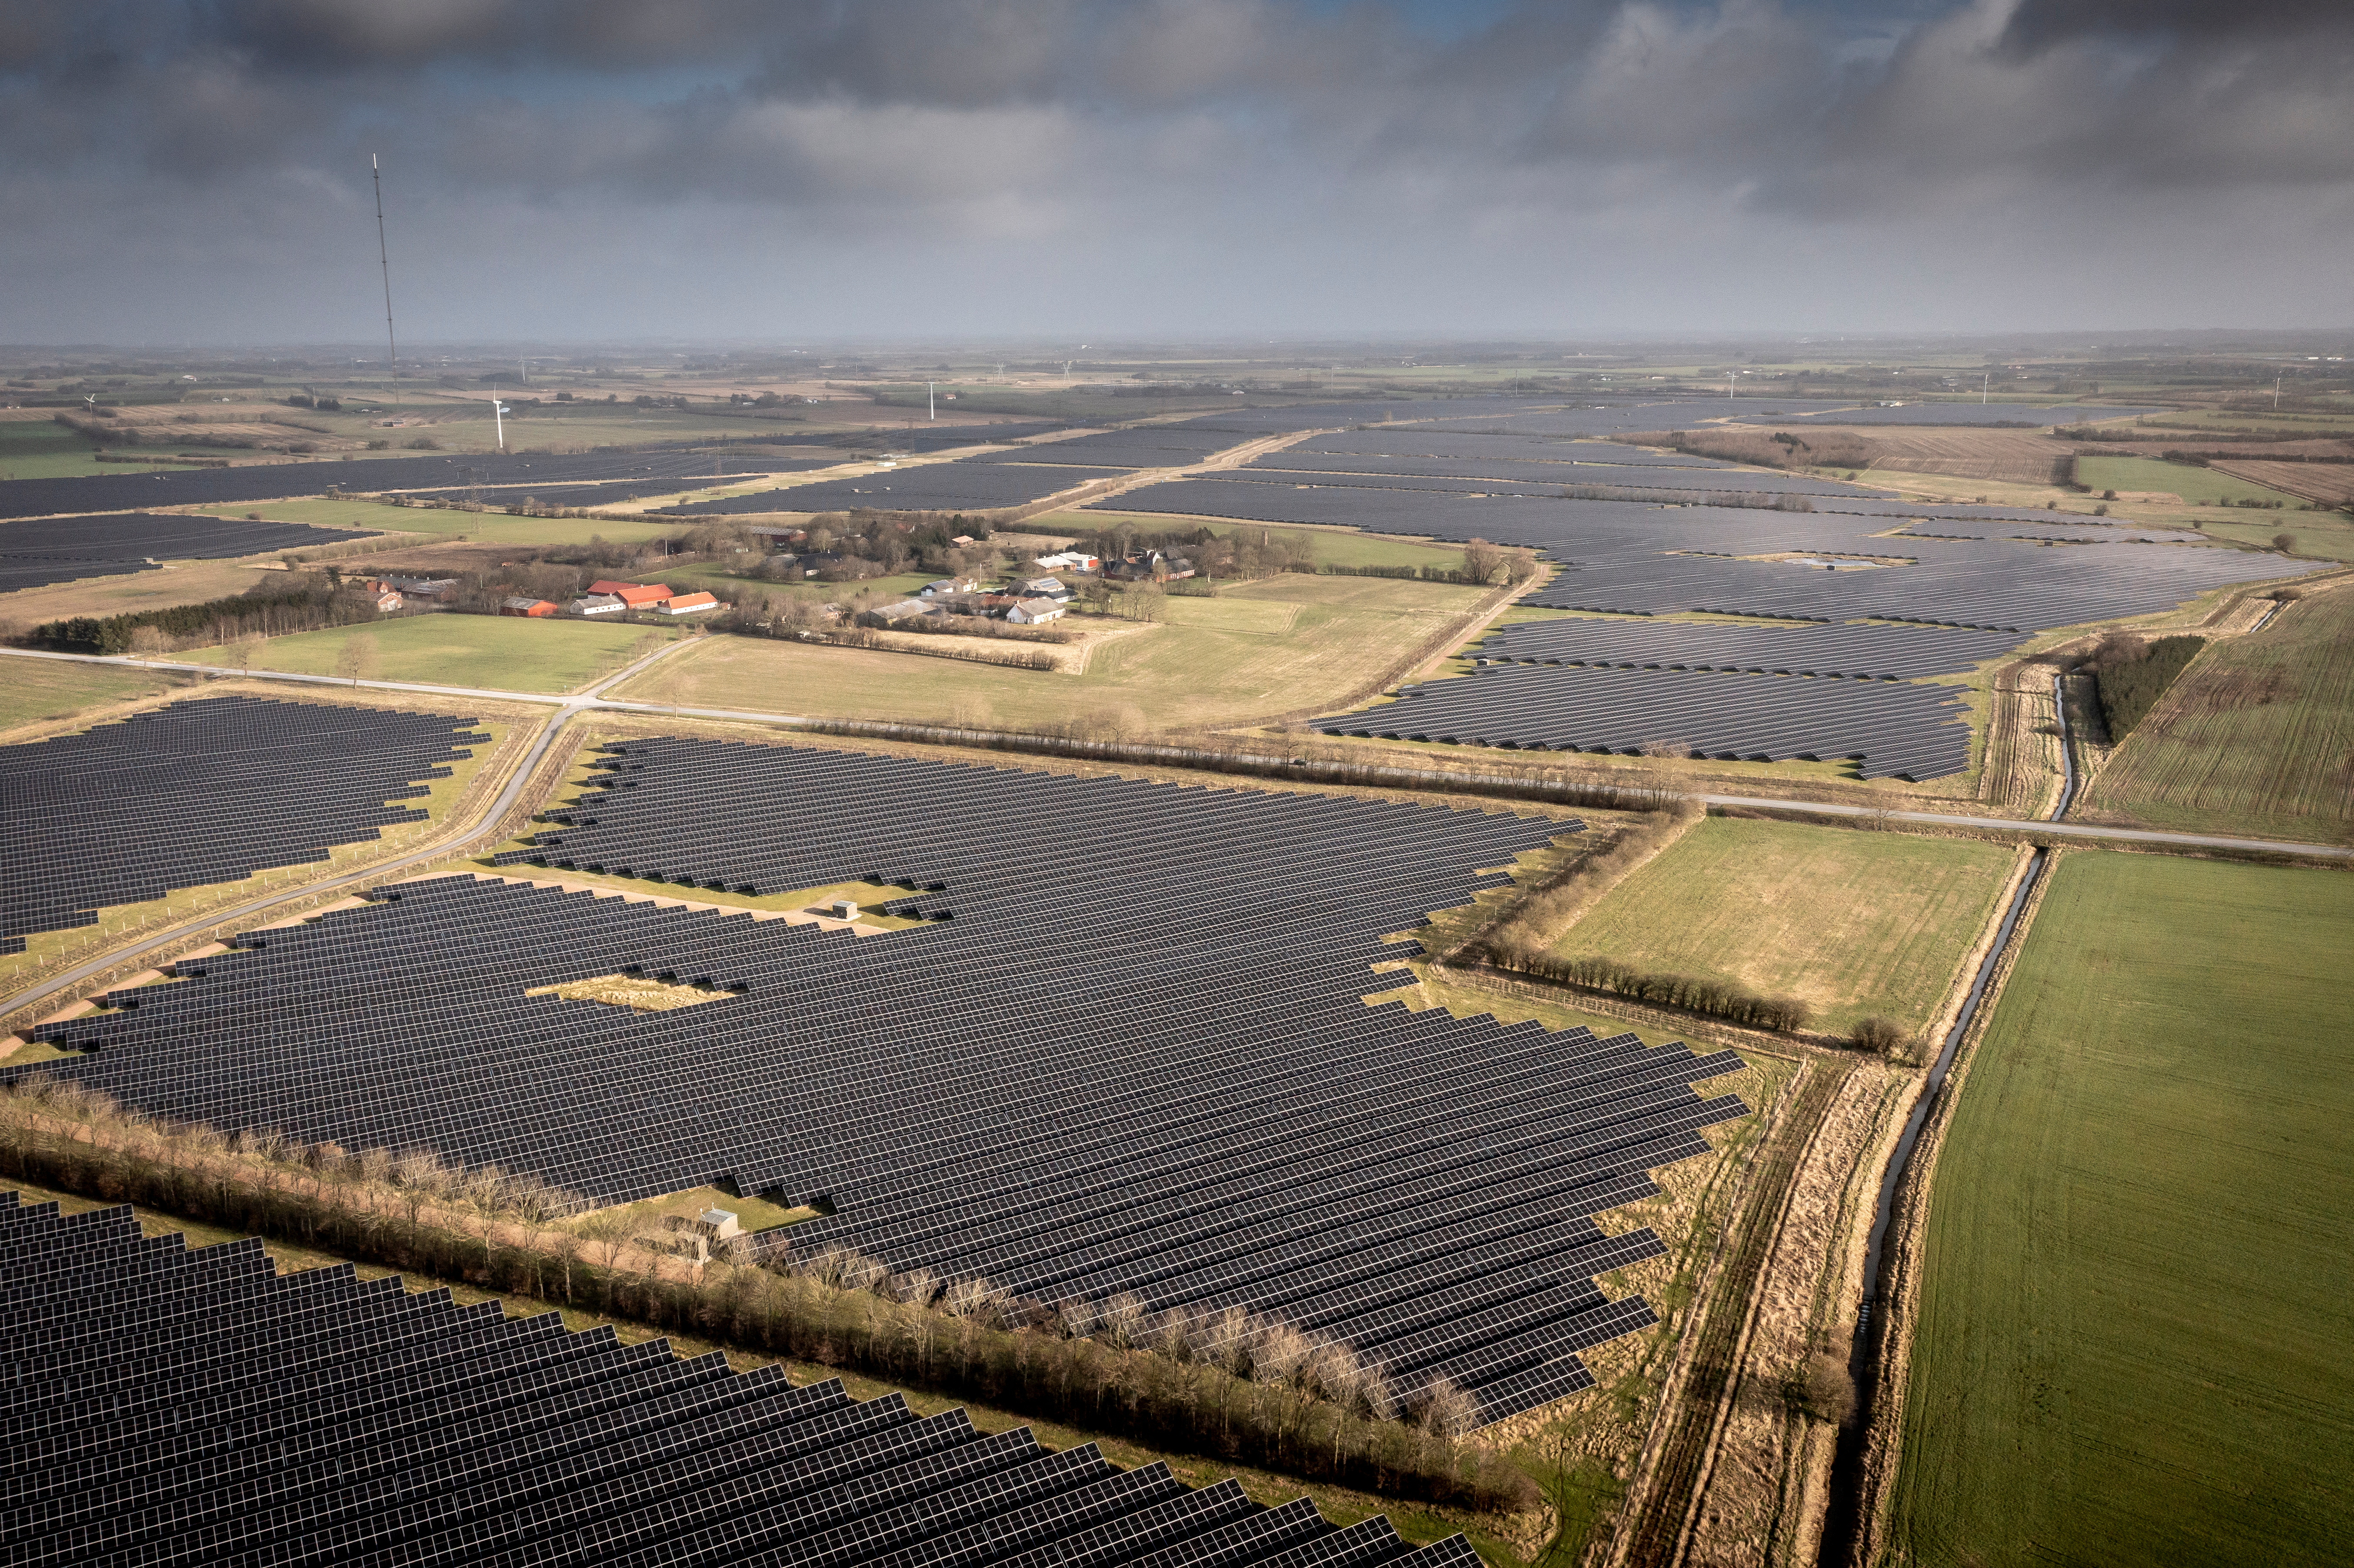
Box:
[18,739,1744,1420]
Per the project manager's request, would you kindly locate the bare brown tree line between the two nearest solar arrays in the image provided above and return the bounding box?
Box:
[0,1074,1537,1511]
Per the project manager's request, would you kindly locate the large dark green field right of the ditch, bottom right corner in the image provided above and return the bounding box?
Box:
[1886,852,2354,1568]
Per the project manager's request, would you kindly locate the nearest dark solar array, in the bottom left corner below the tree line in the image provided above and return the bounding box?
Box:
[0,1191,1478,1568]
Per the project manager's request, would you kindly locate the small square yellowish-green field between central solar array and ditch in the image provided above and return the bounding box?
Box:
[1554,817,2015,1034]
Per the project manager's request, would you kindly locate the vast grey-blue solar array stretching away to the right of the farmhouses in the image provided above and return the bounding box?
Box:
[1059,400,2312,779]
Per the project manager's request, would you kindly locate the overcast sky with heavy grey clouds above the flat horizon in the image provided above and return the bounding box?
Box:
[0,0,2354,344]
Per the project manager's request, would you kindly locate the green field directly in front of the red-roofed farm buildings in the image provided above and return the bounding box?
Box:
[177,615,678,692]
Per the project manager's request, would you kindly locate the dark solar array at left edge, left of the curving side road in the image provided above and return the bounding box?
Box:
[0,697,490,953]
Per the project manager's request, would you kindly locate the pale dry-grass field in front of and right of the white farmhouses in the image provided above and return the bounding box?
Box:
[614,572,1480,730]
